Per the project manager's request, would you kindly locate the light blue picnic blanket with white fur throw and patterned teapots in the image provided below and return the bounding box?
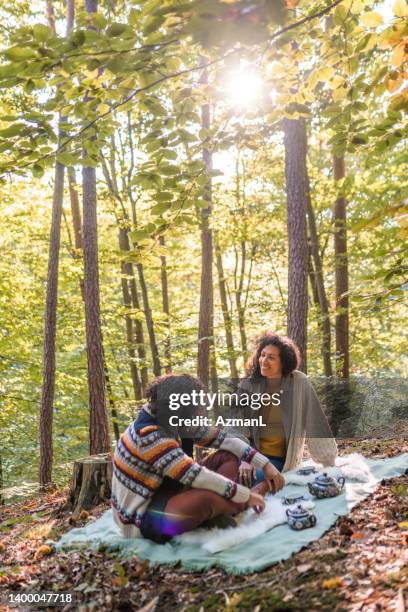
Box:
[55,453,408,574]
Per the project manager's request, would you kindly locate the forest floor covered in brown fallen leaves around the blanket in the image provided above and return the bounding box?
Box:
[0,438,408,612]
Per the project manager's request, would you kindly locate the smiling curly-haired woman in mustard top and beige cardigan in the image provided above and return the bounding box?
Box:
[239,331,337,490]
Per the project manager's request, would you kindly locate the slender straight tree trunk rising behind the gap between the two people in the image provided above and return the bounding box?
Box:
[197,62,214,387]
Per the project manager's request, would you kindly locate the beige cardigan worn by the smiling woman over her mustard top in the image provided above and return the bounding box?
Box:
[240,370,337,472]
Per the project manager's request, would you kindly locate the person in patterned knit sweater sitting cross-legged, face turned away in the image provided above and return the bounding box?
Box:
[112,374,284,542]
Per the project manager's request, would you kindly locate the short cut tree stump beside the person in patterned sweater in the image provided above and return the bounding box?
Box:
[68,453,112,516]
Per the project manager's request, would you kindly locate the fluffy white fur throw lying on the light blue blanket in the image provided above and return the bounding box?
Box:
[175,453,370,553]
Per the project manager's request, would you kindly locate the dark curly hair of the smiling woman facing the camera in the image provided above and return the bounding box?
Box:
[245,331,301,378]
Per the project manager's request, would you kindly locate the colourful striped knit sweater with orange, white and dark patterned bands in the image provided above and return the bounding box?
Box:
[112,406,268,538]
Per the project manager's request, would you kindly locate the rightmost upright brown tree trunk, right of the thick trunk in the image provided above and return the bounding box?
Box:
[333,157,350,380]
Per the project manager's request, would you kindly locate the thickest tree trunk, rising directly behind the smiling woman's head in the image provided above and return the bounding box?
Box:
[283,119,309,372]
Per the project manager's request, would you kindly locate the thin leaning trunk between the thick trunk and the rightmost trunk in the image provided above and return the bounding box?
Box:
[307,188,333,377]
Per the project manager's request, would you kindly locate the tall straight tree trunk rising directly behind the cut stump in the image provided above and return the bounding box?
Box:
[82,0,111,455]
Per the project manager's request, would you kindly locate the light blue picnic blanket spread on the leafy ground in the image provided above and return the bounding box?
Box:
[56,453,408,574]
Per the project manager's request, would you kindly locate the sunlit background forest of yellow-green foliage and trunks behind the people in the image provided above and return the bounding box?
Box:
[0,0,408,498]
